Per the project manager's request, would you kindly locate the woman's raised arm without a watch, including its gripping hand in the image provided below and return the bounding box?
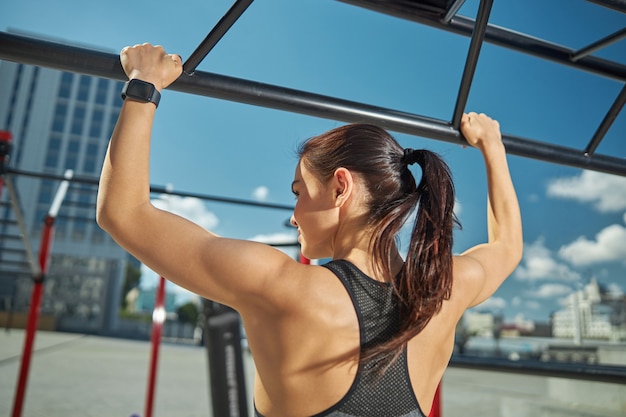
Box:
[454,113,523,307]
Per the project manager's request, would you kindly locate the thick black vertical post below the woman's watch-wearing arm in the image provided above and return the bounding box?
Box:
[203,300,248,417]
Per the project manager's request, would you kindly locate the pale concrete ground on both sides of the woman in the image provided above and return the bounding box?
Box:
[0,330,626,417]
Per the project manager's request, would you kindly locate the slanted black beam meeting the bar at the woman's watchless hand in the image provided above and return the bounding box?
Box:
[452,0,493,129]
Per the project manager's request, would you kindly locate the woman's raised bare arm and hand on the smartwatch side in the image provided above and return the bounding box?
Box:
[97,44,297,309]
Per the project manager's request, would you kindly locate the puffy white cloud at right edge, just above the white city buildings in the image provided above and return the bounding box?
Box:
[559,224,626,266]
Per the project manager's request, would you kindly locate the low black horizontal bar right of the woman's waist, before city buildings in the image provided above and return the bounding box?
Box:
[450,355,626,384]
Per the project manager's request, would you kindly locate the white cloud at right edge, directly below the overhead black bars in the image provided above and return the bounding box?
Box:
[547,171,626,213]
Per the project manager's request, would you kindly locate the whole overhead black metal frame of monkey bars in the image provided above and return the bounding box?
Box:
[0,0,626,176]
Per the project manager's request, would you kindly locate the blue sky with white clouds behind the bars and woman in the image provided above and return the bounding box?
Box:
[0,0,626,321]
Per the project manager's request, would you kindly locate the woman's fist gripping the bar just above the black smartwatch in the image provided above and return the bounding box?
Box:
[120,43,183,91]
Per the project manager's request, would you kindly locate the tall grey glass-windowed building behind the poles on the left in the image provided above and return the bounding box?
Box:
[0,40,128,334]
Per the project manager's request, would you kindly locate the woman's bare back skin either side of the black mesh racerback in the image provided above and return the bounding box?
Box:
[243,266,458,417]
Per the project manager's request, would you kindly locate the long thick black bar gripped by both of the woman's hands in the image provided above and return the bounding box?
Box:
[0,32,626,176]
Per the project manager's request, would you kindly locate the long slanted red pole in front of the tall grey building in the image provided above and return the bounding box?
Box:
[12,215,54,417]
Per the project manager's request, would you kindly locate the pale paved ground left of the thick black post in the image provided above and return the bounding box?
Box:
[0,330,232,417]
